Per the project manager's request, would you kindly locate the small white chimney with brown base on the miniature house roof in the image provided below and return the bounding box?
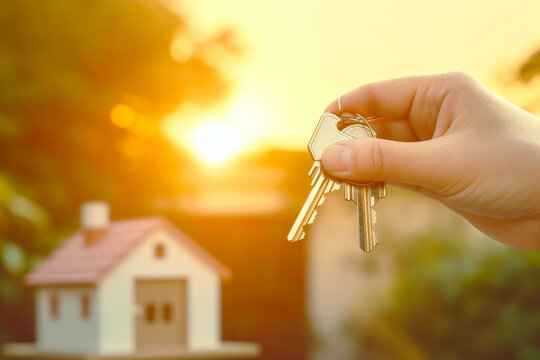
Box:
[81,201,109,246]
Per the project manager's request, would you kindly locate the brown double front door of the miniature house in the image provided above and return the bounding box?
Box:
[135,280,186,349]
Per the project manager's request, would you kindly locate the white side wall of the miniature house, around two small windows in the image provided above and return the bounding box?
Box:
[36,287,98,353]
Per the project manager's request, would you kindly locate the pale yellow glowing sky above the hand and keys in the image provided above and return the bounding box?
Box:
[178,0,540,149]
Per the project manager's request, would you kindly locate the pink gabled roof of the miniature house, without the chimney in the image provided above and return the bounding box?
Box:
[26,217,231,286]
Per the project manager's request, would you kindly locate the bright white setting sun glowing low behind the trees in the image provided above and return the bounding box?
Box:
[189,120,242,165]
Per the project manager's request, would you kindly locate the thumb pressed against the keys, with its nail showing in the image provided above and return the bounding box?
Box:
[322,139,444,190]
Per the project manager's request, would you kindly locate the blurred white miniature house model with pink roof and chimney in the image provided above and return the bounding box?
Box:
[27,202,230,354]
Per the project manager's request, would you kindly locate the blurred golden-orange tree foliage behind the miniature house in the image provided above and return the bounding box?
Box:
[0,0,238,342]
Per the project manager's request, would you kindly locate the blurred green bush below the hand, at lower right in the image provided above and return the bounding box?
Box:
[345,231,540,360]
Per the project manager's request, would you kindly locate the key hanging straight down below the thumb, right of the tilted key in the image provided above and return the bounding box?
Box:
[343,124,386,253]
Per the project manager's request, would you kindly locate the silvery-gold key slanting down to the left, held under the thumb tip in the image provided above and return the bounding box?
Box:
[287,113,352,241]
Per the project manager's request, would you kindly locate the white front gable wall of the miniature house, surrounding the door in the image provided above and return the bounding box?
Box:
[98,230,221,353]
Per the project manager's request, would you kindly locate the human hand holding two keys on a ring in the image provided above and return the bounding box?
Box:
[322,73,540,250]
